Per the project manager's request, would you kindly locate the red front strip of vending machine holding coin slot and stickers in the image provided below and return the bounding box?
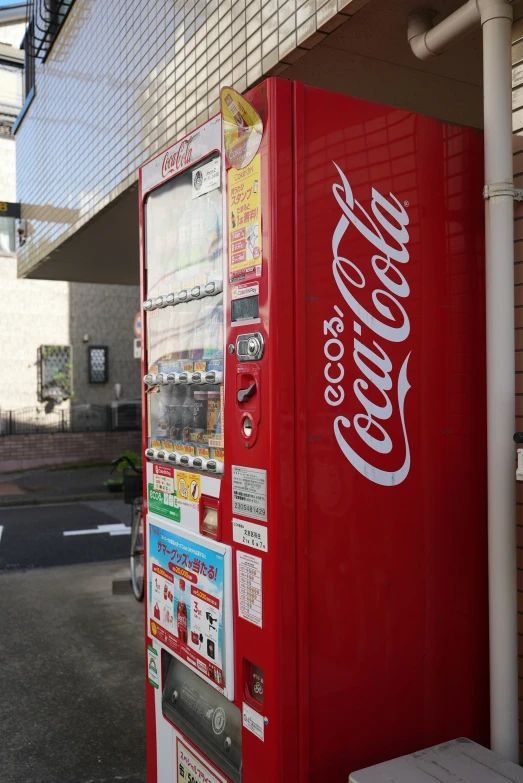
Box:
[223,79,298,783]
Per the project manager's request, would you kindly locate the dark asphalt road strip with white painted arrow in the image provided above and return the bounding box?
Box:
[0,500,131,571]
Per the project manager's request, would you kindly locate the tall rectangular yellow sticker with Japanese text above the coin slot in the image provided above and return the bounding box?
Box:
[227,155,262,282]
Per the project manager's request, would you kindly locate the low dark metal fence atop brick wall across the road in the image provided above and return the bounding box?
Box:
[0,400,142,437]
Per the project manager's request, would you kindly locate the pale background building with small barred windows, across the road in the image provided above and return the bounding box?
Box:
[0,4,140,421]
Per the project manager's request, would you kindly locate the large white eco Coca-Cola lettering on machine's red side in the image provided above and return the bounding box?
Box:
[323,161,410,487]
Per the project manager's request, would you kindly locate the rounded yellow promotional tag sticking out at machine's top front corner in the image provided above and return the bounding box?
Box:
[221,87,263,169]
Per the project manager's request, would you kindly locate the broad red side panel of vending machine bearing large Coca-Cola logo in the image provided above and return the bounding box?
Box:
[295,85,489,783]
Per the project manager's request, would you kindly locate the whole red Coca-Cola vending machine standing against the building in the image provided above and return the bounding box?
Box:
[140,79,489,783]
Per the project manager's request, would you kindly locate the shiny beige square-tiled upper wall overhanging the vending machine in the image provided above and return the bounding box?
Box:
[17,0,369,275]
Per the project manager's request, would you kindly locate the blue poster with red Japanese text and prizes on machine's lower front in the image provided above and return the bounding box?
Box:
[148,524,225,690]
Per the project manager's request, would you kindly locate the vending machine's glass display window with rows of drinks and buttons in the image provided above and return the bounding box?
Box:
[144,153,224,472]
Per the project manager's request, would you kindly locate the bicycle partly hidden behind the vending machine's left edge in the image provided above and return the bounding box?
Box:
[111,455,145,601]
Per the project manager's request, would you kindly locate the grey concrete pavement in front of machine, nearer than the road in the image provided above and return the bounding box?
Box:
[0,561,145,783]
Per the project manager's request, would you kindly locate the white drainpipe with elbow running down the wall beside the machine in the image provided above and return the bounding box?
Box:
[408,0,519,762]
